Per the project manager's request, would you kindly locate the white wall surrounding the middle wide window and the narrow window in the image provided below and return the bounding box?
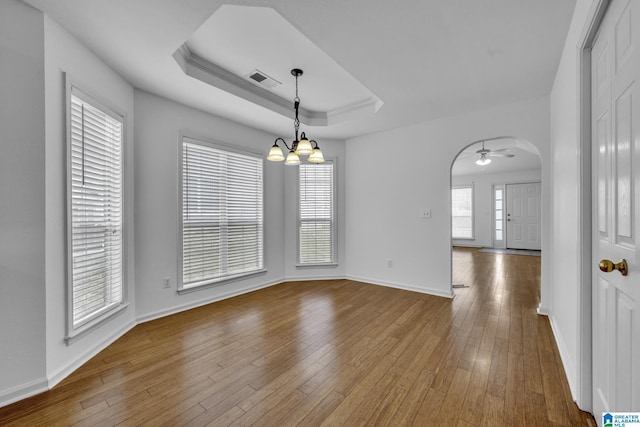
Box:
[135,90,344,320]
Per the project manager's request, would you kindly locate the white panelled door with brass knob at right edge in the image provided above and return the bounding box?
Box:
[591,0,640,424]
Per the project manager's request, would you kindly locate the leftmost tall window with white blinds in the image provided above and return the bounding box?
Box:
[67,87,124,339]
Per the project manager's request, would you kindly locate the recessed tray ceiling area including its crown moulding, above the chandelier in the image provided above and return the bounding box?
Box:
[174,5,382,126]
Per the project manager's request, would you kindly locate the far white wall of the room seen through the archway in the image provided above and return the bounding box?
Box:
[451,169,542,248]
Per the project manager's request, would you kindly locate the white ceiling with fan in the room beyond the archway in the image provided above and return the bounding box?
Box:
[451,137,542,176]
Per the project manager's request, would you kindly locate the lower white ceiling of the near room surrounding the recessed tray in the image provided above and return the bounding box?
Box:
[24,0,575,139]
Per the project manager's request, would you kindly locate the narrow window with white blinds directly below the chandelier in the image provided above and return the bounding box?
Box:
[298,161,335,265]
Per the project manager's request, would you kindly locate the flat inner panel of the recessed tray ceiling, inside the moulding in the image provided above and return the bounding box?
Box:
[181,5,380,117]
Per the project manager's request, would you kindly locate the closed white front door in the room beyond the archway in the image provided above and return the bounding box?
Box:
[506,182,541,250]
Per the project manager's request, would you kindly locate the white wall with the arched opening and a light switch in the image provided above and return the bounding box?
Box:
[346,97,549,296]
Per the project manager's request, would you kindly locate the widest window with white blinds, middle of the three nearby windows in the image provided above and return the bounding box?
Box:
[180,138,263,289]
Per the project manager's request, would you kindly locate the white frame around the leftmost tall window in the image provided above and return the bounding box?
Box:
[65,84,128,345]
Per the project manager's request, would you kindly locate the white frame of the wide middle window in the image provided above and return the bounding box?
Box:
[178,135,266,294]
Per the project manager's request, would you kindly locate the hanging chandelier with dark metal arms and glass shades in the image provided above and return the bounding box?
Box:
[267,68,324,165]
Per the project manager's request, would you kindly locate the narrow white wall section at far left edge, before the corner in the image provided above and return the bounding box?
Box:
[0,0,46,406]
